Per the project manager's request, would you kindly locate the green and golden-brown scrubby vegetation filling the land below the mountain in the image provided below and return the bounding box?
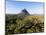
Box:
[5,15,44,34]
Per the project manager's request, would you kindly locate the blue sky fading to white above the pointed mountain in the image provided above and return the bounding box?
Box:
[6,0,44,14]
